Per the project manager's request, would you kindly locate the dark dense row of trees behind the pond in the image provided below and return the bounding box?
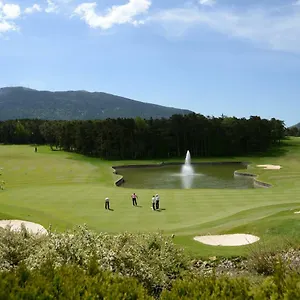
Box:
[0,113,286,159]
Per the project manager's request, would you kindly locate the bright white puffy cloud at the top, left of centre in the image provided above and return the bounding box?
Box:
[74,0,151,30]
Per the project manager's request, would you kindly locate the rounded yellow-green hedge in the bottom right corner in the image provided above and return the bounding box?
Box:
[160,261,300,300]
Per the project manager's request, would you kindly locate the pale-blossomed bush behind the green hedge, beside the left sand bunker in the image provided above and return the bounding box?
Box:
[0,226,188,295]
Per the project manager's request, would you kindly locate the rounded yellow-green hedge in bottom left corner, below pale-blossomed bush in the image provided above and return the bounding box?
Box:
[0,264,151,300]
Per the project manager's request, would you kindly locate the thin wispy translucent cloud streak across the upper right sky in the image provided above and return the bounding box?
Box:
[148,5,300,53]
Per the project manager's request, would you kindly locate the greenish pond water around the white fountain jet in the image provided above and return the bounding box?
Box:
[116,163,254,189]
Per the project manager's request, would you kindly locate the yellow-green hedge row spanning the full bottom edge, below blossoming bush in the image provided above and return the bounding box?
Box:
[0,250,300,300]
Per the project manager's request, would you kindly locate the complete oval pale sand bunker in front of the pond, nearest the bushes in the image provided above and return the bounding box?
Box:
[194,233,259,246]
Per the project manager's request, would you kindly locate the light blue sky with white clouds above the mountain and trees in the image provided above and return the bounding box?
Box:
[0,0,300,126]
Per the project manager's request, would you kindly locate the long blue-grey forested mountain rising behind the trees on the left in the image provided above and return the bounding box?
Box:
[0,87,192,120]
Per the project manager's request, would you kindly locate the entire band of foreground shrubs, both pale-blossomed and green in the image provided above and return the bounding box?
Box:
[0,227,300,300]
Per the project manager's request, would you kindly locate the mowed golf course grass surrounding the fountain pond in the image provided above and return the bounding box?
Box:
[0,138,300,256]
